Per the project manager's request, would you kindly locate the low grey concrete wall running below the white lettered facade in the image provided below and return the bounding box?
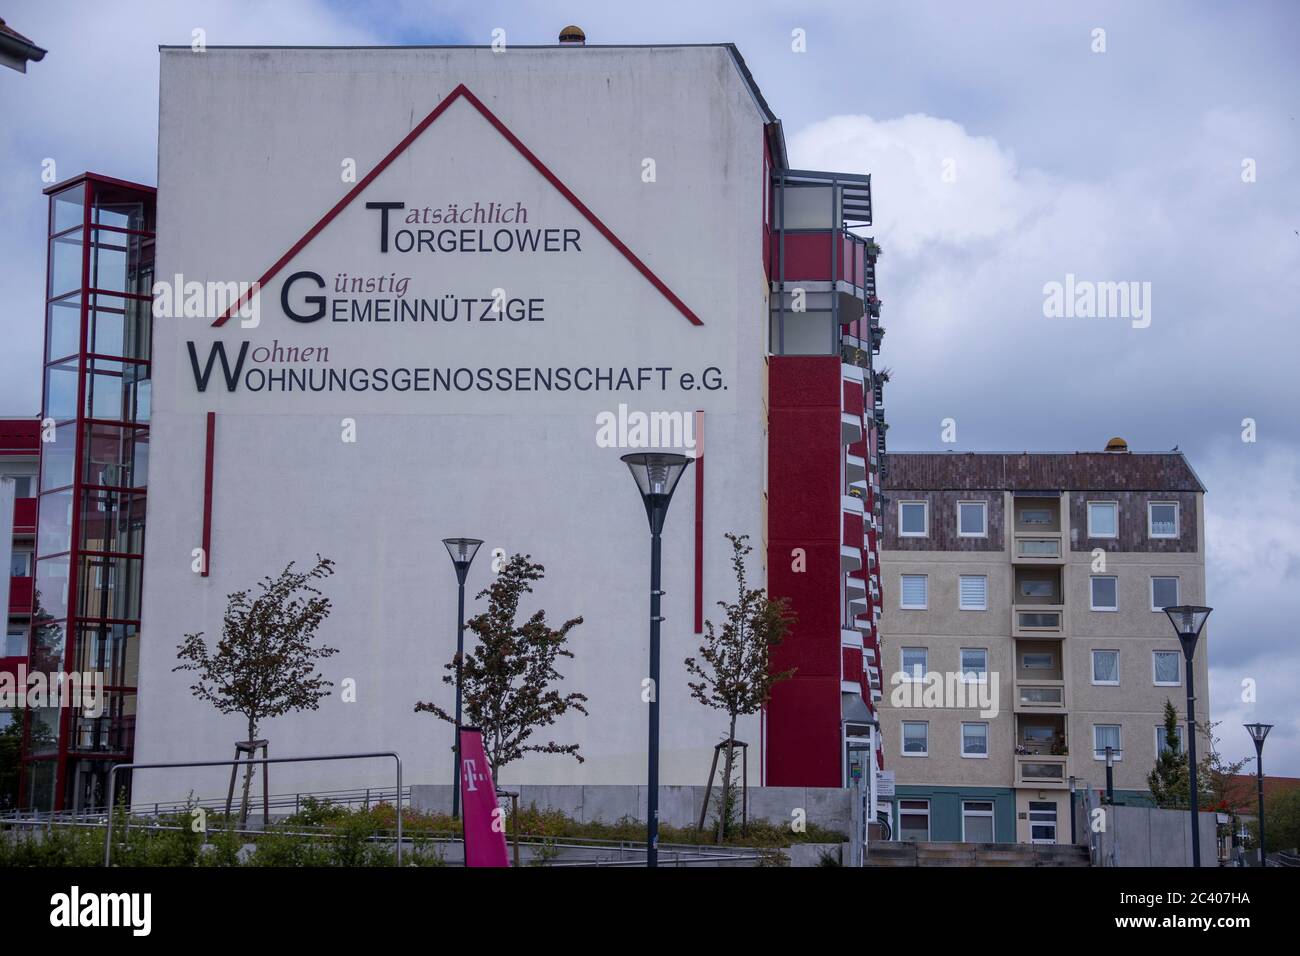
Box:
[411,784,853,834]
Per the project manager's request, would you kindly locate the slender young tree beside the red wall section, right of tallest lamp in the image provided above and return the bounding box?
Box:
[685,532,796,839]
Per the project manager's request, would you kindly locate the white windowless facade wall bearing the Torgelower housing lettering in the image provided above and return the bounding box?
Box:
[135,47,766,803]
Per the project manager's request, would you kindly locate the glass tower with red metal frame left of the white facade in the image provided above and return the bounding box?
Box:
[22,173,156,810]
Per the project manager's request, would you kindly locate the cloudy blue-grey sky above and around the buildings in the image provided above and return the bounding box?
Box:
[0,0,1300,777]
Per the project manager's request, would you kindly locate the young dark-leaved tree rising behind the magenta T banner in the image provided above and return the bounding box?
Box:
[415,554,586,782]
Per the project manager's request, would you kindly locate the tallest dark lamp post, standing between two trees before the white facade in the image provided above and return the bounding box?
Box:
[623,451,692,866]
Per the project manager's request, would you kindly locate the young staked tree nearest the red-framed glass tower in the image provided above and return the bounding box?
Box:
[172,554,338,822]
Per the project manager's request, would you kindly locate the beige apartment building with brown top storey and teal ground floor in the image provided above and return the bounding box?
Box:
[880,438,1209,843]
